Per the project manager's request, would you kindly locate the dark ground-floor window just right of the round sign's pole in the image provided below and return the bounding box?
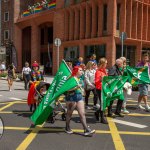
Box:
[64,46,79,64]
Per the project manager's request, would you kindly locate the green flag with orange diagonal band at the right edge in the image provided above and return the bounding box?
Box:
[127,66,150,85]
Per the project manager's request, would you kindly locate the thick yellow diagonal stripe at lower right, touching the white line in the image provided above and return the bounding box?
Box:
[108,118,125,150]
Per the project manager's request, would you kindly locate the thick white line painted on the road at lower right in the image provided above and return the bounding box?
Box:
[111,119,148,129]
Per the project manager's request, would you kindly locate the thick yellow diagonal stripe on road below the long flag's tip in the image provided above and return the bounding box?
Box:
[16,124,44,150]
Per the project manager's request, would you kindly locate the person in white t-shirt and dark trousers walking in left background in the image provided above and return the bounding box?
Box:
[22,62,31,90]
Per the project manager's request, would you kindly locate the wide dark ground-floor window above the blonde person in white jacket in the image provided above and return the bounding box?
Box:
[84,45,106,63]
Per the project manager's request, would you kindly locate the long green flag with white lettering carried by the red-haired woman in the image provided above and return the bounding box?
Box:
[31,60,78,125]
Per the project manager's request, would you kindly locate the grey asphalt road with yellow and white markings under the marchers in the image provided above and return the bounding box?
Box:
[0,80,150,150]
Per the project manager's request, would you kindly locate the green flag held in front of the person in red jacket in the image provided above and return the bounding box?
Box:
[101,76,128,111]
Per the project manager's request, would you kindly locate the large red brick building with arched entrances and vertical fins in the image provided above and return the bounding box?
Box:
[6,0,150,74]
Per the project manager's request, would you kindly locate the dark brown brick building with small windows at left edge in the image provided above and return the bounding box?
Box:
[0,0,14,61]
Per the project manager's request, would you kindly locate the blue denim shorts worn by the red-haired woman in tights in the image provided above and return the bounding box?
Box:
[66,93,83,102]
